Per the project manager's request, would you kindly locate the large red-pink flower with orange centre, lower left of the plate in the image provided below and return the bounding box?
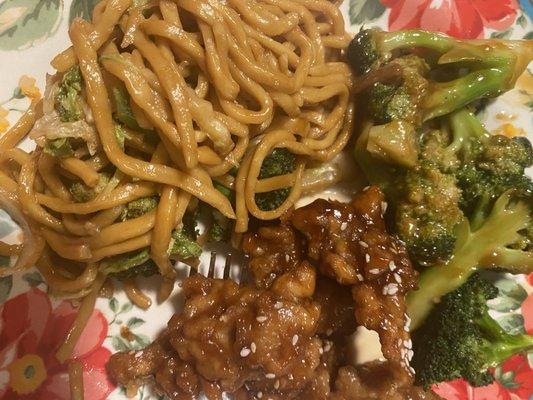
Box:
[0,288,114,400]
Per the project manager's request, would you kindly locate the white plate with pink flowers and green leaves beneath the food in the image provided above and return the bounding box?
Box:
[0,0,533,400]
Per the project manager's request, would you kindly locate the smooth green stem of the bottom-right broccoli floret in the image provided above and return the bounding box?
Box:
[476,315,533,368]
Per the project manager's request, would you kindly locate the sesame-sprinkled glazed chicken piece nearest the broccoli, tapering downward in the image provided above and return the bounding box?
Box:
[287,187,417,368]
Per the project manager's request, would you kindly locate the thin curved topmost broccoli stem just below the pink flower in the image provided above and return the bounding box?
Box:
[377,30,455,53]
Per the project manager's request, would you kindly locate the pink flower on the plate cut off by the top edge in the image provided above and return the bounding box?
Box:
[381,0,519,39]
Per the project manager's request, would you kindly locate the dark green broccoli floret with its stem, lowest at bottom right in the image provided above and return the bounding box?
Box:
[411,274,533,388]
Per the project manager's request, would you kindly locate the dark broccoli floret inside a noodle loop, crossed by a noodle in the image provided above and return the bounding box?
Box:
[255,148,296,211]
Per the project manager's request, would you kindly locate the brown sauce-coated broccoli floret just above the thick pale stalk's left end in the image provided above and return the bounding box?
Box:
[395,163,464,265]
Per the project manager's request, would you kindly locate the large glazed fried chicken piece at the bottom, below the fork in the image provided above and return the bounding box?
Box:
[109,276,323,399]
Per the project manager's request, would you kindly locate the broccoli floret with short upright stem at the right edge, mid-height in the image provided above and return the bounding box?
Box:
[432,109,533,229]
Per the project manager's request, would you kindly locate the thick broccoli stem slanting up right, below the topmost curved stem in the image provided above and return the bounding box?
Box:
[424,68,508,121]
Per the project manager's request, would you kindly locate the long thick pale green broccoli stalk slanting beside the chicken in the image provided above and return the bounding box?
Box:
[407,194,530,329]
